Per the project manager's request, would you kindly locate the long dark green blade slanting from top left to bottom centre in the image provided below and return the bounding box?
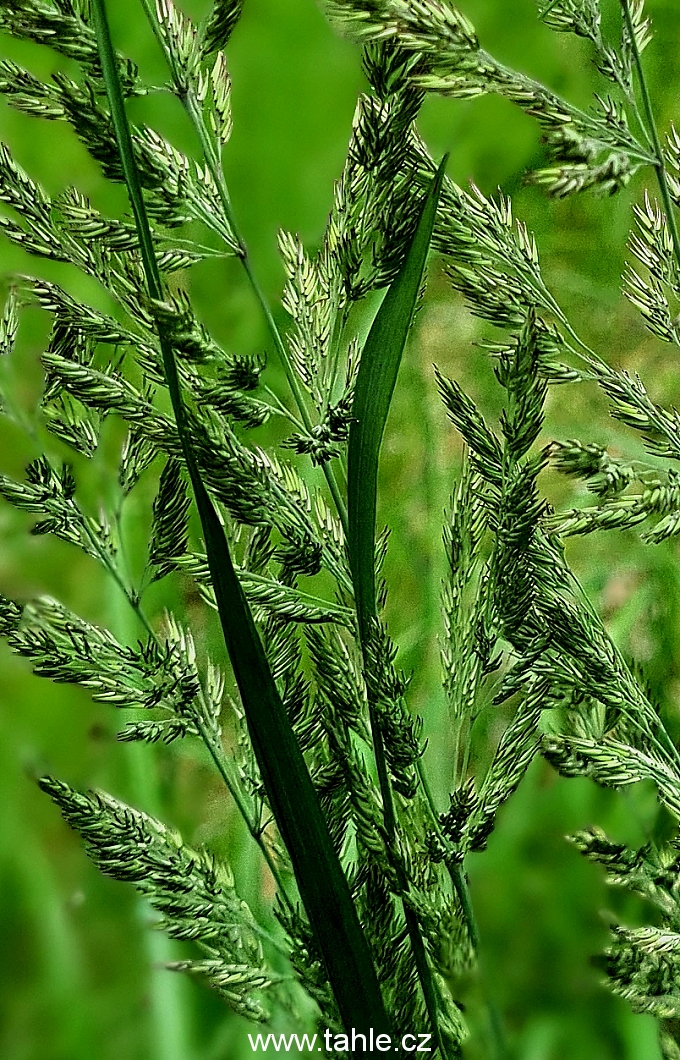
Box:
[92,0,390,1034]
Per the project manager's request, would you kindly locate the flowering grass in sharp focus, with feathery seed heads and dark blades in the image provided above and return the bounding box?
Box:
[0,0,680,1060]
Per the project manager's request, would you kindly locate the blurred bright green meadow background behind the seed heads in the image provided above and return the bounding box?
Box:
[0,0,680,1060]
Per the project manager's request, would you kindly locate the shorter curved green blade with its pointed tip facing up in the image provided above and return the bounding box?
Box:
[347,155,448,644]
